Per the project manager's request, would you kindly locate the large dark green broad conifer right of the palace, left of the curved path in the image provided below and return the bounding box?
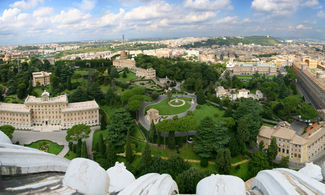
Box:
[106,109,135,147]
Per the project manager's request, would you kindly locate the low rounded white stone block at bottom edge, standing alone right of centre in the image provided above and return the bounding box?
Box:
[196,174,246,195]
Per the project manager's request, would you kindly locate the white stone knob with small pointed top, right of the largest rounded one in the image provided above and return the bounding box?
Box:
[106,162,135,193]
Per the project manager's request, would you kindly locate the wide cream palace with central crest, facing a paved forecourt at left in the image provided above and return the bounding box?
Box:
[0,91,99,131]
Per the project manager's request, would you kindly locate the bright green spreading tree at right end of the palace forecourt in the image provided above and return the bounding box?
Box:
[65,124,90,141]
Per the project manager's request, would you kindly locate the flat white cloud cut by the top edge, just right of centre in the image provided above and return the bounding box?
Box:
[184,0,232,11]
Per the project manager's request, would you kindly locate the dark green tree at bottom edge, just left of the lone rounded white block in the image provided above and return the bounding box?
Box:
[176,167,206,194]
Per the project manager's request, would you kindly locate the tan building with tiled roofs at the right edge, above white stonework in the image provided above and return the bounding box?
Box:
[257,125,325,163]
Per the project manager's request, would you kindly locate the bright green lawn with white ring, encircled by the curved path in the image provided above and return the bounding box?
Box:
[146,98,192,115]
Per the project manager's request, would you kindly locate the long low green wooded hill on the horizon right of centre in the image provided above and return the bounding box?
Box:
[184,36,280,48]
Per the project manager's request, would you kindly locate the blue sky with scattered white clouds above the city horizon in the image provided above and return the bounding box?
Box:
[0,0,325,45]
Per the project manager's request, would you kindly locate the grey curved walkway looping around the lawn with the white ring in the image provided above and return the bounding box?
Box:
[139,95,197,131]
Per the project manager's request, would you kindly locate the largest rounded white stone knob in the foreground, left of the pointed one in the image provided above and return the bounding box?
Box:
[63,158,109,195]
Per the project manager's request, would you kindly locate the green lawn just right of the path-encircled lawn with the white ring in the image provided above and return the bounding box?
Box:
[193,104,225,123]
